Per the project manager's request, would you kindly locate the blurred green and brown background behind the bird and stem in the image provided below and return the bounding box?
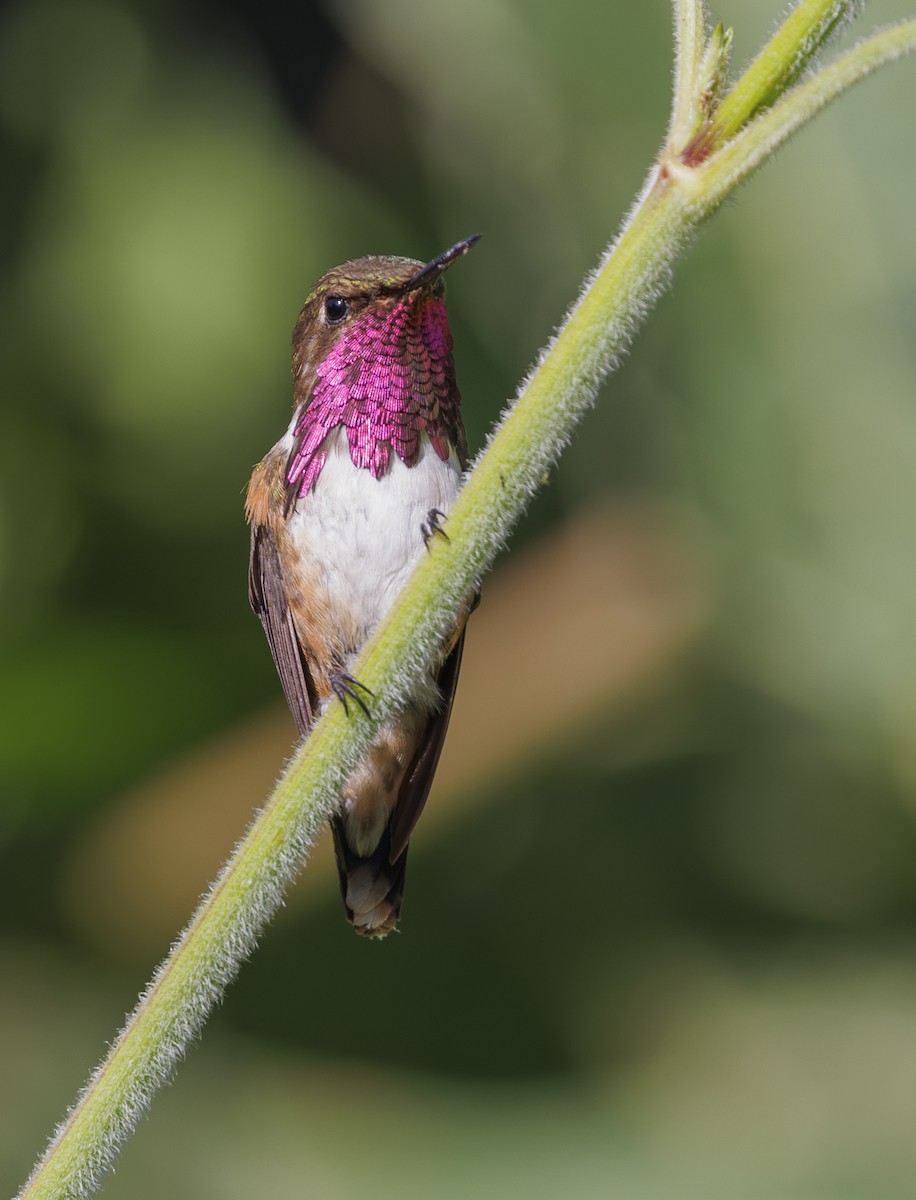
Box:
[0,0,916,1200]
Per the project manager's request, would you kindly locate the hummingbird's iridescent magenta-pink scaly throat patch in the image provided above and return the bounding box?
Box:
[286,293,467,496]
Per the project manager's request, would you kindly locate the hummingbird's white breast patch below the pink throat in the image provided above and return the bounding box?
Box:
[289,431,461,650]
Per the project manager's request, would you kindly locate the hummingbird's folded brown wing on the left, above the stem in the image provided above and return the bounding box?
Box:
[249,524,318,737]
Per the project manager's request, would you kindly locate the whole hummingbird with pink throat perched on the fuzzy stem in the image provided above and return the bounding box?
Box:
[245,235,479,937]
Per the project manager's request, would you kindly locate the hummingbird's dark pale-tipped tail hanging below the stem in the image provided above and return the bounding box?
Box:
[331,816,407,937]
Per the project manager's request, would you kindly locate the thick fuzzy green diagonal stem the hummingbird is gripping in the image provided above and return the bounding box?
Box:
[19,4,916,1200]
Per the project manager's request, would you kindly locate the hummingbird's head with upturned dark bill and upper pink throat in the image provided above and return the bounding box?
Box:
[293,234,479,407]
